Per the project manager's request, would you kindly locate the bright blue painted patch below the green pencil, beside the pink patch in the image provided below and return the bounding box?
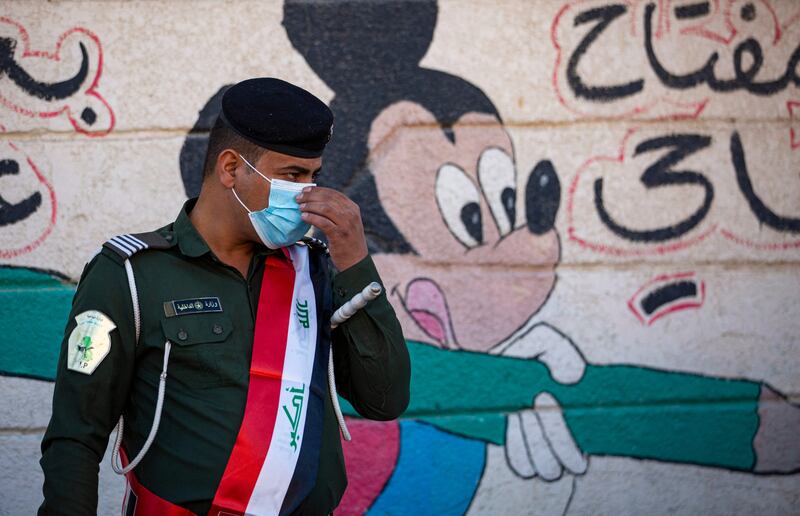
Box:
[368,421,486,516]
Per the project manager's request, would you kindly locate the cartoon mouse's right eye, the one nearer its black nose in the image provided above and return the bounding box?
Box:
[478,148,517,235]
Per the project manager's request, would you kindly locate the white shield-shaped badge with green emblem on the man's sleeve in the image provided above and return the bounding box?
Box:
[67,310,117,374]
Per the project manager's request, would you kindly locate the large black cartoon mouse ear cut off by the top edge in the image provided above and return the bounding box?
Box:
[283,0,438,92]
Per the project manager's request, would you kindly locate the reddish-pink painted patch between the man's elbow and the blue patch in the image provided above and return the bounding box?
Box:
[336,418,400,515]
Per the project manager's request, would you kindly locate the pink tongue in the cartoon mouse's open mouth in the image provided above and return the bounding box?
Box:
[405,278,455,347]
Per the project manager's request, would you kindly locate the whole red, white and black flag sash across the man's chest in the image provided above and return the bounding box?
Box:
[209,245,323,516]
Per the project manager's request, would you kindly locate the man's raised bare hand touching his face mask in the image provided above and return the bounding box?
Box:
[297,186,367,271]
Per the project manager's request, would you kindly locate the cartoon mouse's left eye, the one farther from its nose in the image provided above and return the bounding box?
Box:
[436,163,483,249]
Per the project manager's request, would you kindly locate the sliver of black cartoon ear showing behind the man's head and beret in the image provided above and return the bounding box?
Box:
[179,84,233,198]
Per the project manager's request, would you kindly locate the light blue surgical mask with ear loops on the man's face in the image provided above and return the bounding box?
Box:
[231,154,316,249]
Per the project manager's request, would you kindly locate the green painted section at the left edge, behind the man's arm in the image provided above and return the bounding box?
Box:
[0,267,75,380]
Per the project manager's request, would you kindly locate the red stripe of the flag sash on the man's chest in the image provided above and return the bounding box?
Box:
[208,254,295,516]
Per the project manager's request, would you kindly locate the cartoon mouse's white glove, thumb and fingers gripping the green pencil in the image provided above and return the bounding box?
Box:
[502,323,589,482]
